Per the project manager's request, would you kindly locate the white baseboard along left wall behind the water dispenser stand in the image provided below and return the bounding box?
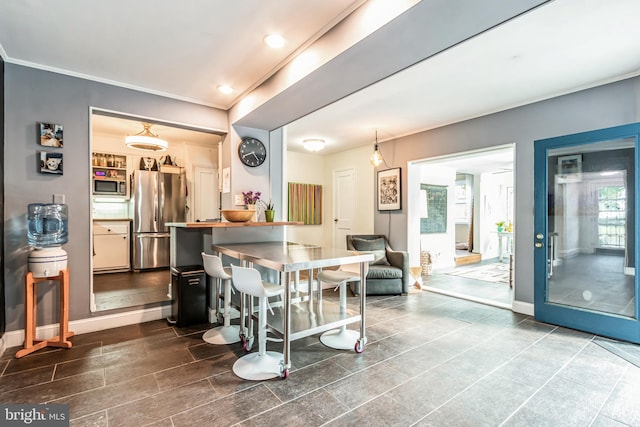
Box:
[0,306,171,354]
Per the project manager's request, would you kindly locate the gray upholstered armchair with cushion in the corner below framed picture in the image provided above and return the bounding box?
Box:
[347,234,411,295]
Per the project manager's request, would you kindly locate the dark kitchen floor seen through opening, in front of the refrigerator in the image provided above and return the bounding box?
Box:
[93,268,171,311]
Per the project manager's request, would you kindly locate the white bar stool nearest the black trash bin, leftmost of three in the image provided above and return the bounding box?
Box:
[202,252,240,344]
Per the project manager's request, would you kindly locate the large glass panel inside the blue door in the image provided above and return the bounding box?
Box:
[547,138,635,317]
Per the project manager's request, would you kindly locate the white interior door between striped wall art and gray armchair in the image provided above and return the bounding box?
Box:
[333,169,355,248]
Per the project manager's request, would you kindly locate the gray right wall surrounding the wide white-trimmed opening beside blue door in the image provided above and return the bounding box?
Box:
[374,77,640,304]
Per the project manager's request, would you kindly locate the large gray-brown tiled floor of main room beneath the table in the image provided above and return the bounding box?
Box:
[0,290,640,427]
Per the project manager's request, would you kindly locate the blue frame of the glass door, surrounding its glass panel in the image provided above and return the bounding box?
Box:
[532,123,640,343]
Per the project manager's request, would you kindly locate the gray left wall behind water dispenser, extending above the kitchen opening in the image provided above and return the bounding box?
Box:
[3,64,227,331]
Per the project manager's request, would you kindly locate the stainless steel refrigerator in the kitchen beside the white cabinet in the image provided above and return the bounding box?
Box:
[131,170,186,270]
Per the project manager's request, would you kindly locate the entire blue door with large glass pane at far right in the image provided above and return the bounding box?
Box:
[533,124,640,343]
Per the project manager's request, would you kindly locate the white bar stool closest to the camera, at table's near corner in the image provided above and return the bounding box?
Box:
[231,265,284,381]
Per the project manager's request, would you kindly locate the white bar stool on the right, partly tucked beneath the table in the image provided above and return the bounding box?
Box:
[317,264,360,350]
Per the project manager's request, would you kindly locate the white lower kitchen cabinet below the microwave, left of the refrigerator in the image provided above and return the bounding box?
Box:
[93,221,131,273]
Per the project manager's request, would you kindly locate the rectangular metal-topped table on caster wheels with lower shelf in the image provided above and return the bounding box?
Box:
[211,241,374,378]
